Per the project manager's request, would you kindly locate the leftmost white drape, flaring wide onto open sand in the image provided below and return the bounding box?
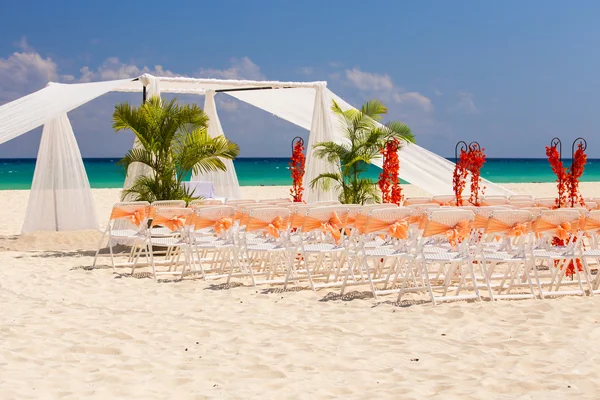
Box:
[22,114,98,233]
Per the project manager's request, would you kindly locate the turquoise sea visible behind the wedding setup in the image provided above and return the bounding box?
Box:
[0,158,600,189]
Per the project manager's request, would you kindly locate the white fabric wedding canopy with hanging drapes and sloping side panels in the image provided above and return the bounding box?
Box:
[0,74,511,232]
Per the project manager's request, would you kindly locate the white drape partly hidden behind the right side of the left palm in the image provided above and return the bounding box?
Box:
[191,89,242,199]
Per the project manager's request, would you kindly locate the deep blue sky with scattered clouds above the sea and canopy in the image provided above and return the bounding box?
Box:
[0,0,600,158]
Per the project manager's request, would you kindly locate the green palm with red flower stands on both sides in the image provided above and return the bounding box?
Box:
[311,100,415,204]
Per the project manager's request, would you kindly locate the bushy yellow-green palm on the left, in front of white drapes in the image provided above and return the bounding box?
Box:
[113,97,239,202]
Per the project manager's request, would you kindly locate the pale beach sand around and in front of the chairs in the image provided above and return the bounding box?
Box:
[0,183,600,399]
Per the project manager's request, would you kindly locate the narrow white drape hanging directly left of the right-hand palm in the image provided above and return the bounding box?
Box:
[302,86,339,202]
